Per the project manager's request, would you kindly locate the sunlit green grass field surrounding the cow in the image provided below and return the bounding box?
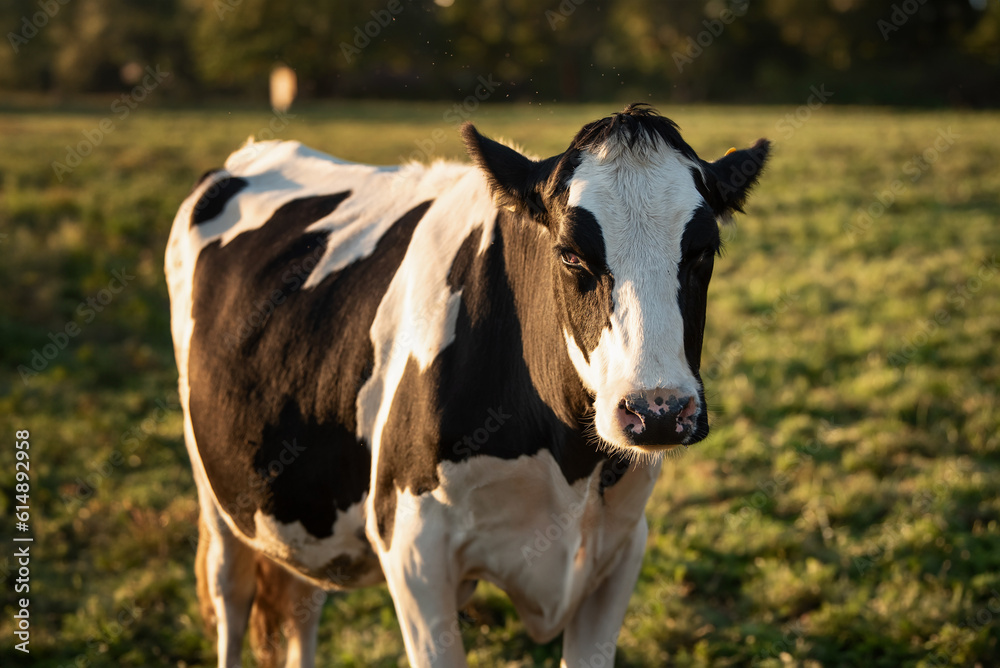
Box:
[0,100,1000,668]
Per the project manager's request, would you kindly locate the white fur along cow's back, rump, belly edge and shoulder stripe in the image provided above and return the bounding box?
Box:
[165,141,495,584]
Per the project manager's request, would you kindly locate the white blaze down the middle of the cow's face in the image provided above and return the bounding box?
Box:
[565,141,704,447]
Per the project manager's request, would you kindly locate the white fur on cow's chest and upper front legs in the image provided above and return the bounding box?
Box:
[381,450,660,666]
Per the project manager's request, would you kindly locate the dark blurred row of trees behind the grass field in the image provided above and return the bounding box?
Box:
[0,0,1000,106]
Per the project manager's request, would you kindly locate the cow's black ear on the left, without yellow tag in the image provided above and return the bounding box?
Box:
[462,123,547,221]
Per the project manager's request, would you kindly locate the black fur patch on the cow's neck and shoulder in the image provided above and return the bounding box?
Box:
[375,219,626,544]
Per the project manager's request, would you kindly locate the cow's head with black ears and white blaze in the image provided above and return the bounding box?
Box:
[462,104,769,454]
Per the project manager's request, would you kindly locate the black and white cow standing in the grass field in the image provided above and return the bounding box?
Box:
[166,104,769,668]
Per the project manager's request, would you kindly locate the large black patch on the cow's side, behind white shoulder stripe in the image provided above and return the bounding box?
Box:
[188,193,430,538]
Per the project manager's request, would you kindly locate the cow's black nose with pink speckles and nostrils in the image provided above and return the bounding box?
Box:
[615,388,701,448]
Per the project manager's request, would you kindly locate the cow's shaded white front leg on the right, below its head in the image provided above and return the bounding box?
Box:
[560,517,649,668]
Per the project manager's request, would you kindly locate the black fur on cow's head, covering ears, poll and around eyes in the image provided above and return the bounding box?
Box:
[462,103,770,454]
